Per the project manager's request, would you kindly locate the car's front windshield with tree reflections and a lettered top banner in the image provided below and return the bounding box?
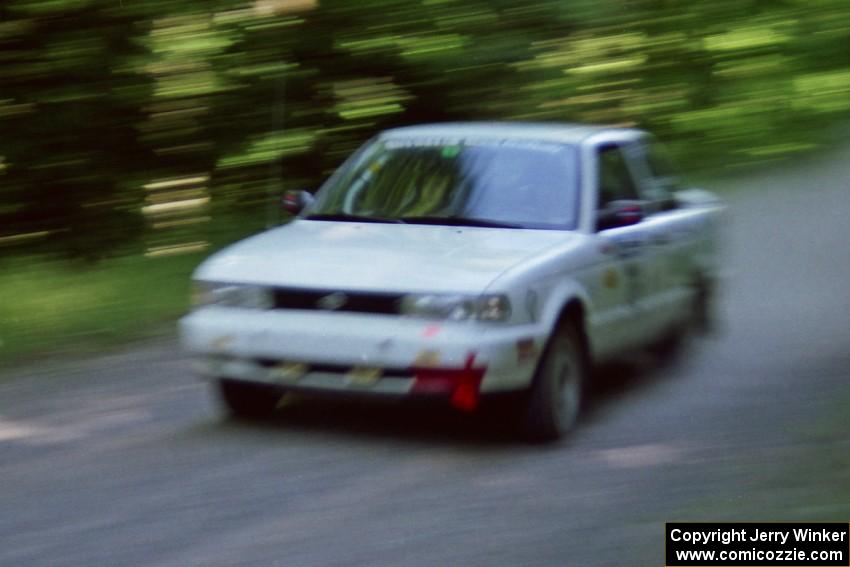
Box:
[305,139,578,230]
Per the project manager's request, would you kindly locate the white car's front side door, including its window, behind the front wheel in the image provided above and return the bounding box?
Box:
[594,142,647,351]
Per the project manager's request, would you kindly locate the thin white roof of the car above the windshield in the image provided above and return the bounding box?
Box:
[380,122,641,144]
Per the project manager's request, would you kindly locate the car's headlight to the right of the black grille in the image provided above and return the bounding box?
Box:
[399,295,511,321]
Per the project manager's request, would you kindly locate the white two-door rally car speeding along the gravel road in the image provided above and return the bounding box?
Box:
[180,123,723,439]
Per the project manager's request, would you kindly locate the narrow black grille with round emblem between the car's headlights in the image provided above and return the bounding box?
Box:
[273,288,402,315]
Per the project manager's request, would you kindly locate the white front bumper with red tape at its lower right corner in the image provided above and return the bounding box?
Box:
[180,306,545,396]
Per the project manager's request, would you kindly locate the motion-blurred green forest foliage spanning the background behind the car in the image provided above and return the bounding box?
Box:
[0,0,850,260]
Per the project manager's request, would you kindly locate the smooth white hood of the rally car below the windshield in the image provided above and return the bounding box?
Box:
[195,220,577,293]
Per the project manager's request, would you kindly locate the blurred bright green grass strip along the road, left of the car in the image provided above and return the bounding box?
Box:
[0,253,206,364]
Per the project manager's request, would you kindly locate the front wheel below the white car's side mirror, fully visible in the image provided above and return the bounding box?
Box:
[522,321,588,441]
